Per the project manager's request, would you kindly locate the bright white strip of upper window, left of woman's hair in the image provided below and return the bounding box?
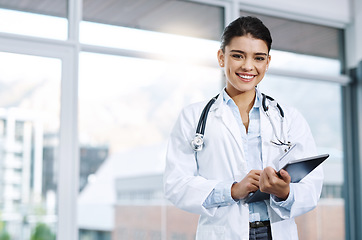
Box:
[80,22,220,62]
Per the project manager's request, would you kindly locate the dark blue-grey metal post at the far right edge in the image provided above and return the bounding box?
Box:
[342,61,362,239]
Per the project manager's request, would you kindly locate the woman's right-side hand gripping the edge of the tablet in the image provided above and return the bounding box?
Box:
[259,167,291,200]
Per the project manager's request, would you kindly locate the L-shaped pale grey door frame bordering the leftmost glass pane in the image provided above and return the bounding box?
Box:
[0,34,79,239]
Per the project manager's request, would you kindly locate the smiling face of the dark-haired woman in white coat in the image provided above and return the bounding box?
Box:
[218,35,271,97]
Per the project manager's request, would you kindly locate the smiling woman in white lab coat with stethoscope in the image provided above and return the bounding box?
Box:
[164,17,323,240]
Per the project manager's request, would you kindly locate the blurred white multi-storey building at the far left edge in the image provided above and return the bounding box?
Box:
[0,108,43,237]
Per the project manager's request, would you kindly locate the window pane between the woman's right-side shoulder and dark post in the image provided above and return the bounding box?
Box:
[259,75,344,240]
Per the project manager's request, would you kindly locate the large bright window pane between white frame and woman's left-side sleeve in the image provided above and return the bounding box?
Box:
[78,53,221,239]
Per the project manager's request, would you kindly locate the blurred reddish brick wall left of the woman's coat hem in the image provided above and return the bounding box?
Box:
[112,206,199,240]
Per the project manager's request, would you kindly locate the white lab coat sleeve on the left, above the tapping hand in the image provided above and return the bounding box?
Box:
[164,107,219,216]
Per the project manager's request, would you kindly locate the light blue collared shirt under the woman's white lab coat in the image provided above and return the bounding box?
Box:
[203,90,292,222]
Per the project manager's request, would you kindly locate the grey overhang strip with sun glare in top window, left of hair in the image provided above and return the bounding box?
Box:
[80,0,224,41]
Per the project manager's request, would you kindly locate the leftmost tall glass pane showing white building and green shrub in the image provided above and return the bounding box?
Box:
[0,53,61,240]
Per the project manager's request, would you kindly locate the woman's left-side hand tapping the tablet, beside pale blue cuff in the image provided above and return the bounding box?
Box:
[231,170,262,200]
